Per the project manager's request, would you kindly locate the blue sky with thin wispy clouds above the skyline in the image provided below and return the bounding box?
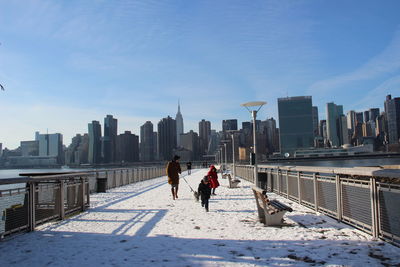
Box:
[0,0,400,148]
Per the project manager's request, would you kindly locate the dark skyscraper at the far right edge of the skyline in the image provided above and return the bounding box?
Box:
[385,95,400,144]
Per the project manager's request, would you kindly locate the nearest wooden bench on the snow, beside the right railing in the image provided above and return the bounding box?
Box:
[253,186,293,226]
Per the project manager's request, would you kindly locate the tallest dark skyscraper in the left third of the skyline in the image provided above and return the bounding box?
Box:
[102,115,118,163]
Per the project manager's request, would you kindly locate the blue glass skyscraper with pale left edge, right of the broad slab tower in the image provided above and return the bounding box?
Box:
[326,102,347,147]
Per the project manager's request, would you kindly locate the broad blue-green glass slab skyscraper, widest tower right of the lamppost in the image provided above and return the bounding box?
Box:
[278,96,314,156]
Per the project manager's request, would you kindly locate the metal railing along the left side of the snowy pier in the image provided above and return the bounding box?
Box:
[0,164,177,240]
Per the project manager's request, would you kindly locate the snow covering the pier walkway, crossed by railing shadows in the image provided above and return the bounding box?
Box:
[0,169,400,266]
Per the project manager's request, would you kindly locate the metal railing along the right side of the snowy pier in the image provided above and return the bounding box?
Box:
[236,165,400,248]
